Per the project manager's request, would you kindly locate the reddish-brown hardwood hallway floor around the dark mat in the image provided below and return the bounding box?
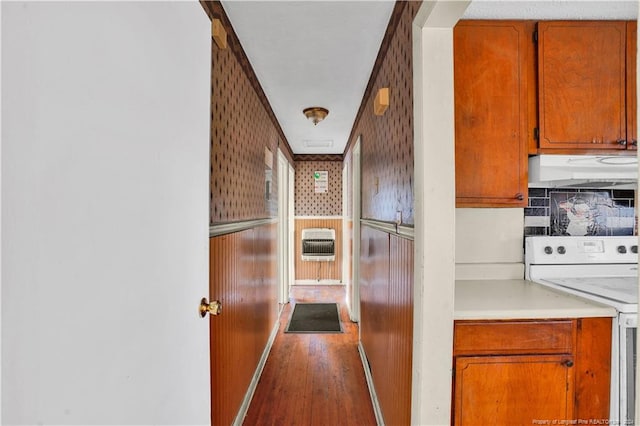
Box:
[244,286,376,426]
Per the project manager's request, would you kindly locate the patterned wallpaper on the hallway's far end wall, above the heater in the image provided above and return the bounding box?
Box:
[295,161,342,216]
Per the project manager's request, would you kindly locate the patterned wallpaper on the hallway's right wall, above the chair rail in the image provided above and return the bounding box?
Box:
[345,1,421,225]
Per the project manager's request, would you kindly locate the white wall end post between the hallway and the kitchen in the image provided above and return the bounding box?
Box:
[411,0,468,425]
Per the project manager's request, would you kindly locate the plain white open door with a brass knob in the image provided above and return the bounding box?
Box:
[2,2,211,425]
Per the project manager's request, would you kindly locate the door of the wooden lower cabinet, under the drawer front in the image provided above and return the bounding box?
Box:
[454,355,575,426]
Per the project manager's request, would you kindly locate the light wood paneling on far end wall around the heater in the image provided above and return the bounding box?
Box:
[294,217,343,284]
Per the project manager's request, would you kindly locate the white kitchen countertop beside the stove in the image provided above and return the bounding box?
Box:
[454,280,616,320]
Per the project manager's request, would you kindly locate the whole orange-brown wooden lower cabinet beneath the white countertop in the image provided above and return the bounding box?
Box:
[453,318,611,426]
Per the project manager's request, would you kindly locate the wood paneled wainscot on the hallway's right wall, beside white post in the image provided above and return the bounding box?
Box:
[360,226,413,425]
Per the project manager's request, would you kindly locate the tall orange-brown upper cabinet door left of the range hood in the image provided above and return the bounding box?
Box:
[454,21,534,207]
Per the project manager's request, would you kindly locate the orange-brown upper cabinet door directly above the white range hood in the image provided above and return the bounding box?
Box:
[538,21,627,150]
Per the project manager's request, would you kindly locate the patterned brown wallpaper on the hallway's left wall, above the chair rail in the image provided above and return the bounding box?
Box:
[210,27,280,224]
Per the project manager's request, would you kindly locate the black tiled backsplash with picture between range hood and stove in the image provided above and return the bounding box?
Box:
[524,188,637,236]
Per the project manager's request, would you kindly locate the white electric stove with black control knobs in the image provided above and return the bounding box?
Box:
[525,236,638,425]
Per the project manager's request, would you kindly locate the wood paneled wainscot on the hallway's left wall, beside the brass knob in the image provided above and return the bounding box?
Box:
[209,224,278,426]
